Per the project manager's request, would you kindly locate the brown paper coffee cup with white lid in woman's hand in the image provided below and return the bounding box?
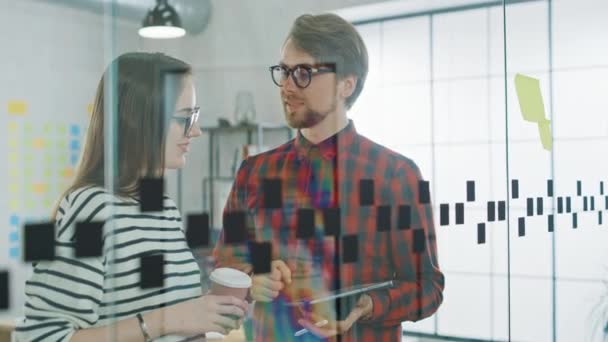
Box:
[209,267,251,300]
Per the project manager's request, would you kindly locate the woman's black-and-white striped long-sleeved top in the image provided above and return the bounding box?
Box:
[16,187,201,341]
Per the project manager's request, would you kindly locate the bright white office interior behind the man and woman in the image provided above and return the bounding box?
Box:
[0,0,608,341]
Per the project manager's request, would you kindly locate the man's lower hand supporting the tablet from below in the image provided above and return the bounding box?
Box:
[298,294,374,338]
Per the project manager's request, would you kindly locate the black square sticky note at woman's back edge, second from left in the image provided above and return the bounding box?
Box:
[22,223,55,262]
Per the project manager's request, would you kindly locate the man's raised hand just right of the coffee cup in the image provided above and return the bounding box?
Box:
[251,260,291,302]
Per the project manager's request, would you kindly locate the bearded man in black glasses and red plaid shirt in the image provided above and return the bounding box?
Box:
[214,14,444,341]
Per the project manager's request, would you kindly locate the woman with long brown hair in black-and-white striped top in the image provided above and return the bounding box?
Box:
[16,53,247,341]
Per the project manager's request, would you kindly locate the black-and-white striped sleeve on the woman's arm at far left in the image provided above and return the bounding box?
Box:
[15,188,109,341]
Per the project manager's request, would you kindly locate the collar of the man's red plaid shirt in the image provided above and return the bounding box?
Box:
[295,120,357,159]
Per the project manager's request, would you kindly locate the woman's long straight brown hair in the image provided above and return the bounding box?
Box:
[53,52,191,218]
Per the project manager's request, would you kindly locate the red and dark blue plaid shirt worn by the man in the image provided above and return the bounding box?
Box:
[213,121,444,342]
